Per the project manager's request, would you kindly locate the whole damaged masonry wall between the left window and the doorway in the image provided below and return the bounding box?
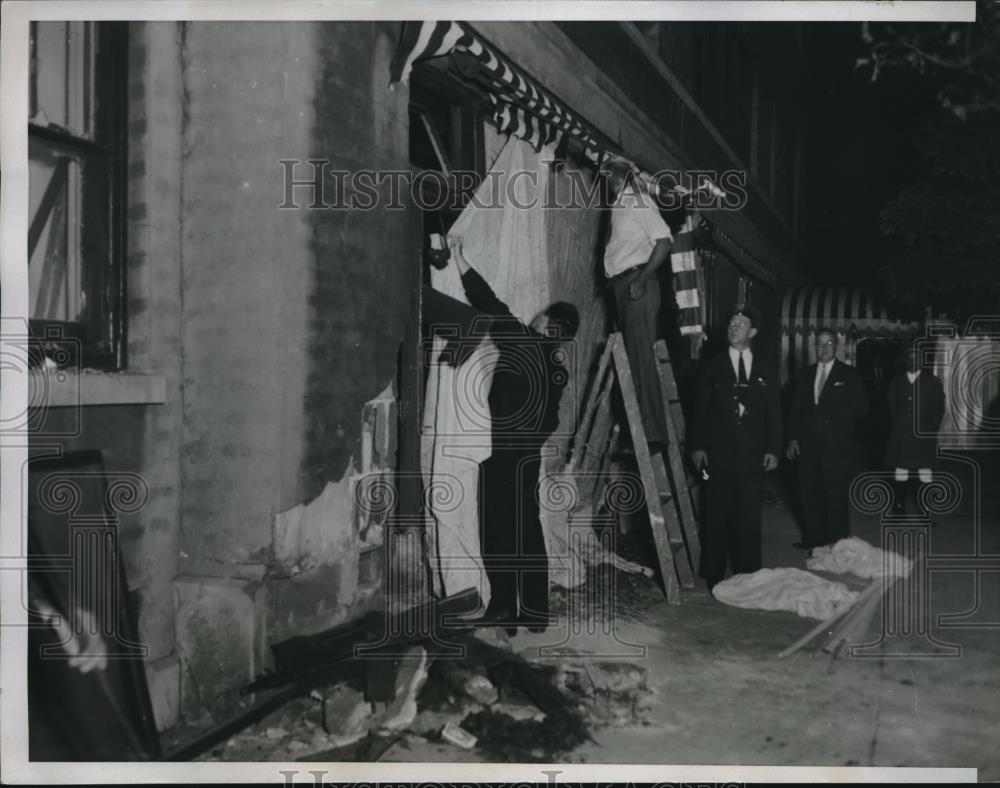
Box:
[33,22,410,729]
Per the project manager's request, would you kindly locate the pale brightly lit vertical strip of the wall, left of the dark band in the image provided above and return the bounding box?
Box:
[180,22,316,576]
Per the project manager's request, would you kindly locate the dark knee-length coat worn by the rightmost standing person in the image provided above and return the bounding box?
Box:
[885,370,945,468]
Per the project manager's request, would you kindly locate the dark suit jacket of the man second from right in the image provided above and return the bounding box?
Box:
[788,359,868,463]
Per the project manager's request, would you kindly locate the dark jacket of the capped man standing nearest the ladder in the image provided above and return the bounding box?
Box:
[691,348,781,472]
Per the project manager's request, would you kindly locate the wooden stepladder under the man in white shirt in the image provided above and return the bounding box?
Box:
[570,332,700,604]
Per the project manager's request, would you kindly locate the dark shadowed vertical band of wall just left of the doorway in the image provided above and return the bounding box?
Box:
[301,22,420,498]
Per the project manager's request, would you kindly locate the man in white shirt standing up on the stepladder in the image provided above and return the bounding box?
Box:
[604,162,673,448]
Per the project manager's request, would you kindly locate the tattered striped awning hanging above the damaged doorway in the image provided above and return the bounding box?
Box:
[389,21,614,161]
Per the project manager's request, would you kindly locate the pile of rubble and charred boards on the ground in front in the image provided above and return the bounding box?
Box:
[171,592,649,762]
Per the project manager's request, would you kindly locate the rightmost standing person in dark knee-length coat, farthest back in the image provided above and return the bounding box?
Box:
[885,350,945,517]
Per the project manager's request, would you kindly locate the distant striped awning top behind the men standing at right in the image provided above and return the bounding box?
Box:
[781,285,919,334]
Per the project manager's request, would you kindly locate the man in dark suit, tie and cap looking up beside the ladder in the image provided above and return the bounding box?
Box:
[691,308,781,590]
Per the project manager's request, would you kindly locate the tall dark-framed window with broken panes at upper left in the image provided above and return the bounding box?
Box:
[28,21,127,369]
